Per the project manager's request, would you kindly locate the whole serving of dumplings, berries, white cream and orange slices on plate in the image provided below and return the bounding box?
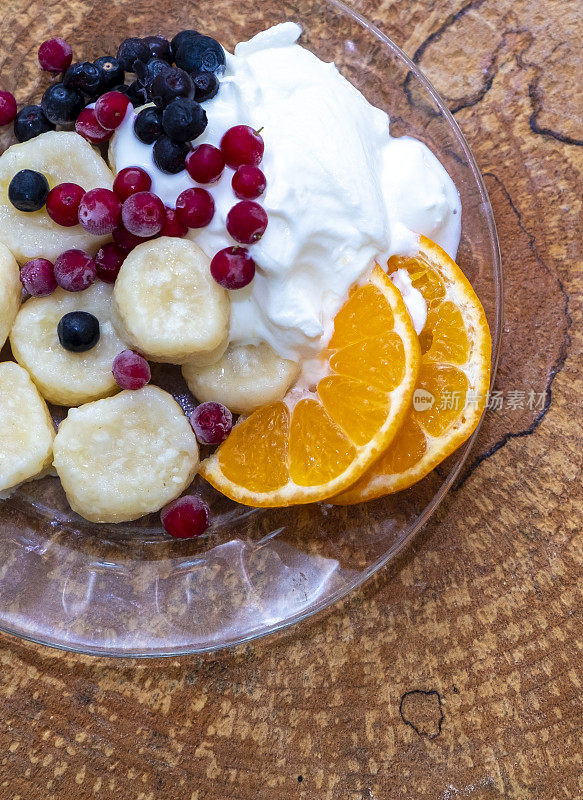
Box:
[0,22,490,538]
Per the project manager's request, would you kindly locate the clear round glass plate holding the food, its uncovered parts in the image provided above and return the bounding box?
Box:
[0,0,502,656]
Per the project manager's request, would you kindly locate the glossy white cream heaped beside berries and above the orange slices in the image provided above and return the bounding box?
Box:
[112,22,461,361]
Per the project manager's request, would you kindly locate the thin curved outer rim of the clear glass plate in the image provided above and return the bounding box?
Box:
[0,0,503,659]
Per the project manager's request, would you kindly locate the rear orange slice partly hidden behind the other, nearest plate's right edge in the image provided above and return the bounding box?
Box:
[331,236,492,505]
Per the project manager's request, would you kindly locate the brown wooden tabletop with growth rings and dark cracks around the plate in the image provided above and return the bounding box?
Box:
[0,0,583,800]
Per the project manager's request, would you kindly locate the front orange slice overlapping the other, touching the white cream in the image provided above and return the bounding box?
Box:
[200,266,421,506]
